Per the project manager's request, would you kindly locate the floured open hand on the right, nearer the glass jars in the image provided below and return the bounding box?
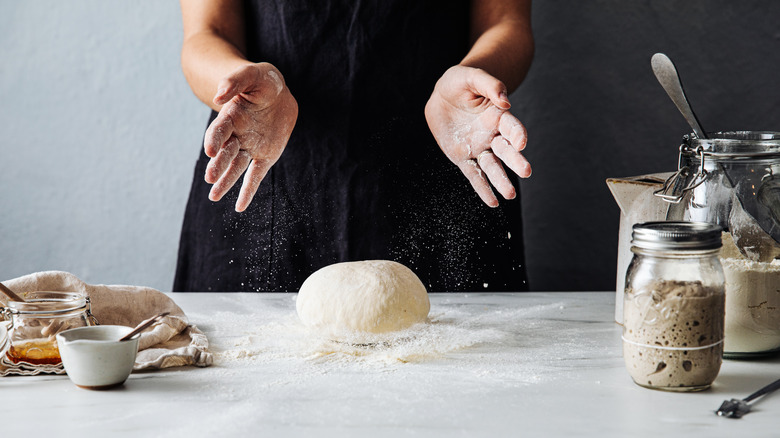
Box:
[425,65,531,207]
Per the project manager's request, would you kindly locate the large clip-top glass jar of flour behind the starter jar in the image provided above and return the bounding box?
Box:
[658,131,780,358]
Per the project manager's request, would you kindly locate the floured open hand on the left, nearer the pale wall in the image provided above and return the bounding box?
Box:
[203,63,298,212]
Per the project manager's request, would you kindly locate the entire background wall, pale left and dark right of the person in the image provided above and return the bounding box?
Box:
[0,0,780,290]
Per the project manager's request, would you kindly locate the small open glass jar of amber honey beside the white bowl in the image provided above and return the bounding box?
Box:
[0,292,97,365]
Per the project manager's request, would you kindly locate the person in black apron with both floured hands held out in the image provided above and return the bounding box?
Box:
[173,0,533,292]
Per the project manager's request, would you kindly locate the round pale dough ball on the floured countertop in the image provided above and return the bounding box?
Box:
[296,260,431,336]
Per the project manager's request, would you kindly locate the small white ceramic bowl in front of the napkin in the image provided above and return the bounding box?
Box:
[57,325,140,389]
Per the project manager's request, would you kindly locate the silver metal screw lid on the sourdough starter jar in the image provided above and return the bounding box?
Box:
[631,221,723,250]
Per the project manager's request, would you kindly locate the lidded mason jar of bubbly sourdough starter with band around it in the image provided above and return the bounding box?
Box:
[623,222,725,391]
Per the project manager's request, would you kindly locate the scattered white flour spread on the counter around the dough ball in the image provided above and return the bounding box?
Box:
[184,294,619,387]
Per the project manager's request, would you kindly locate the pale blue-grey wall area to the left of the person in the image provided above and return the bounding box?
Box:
[0,0,207,290]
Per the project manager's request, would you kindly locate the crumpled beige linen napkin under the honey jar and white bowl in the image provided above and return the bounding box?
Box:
[0,271,213,376]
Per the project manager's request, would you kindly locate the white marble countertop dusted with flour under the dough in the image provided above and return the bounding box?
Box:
[0,292,780,438]
